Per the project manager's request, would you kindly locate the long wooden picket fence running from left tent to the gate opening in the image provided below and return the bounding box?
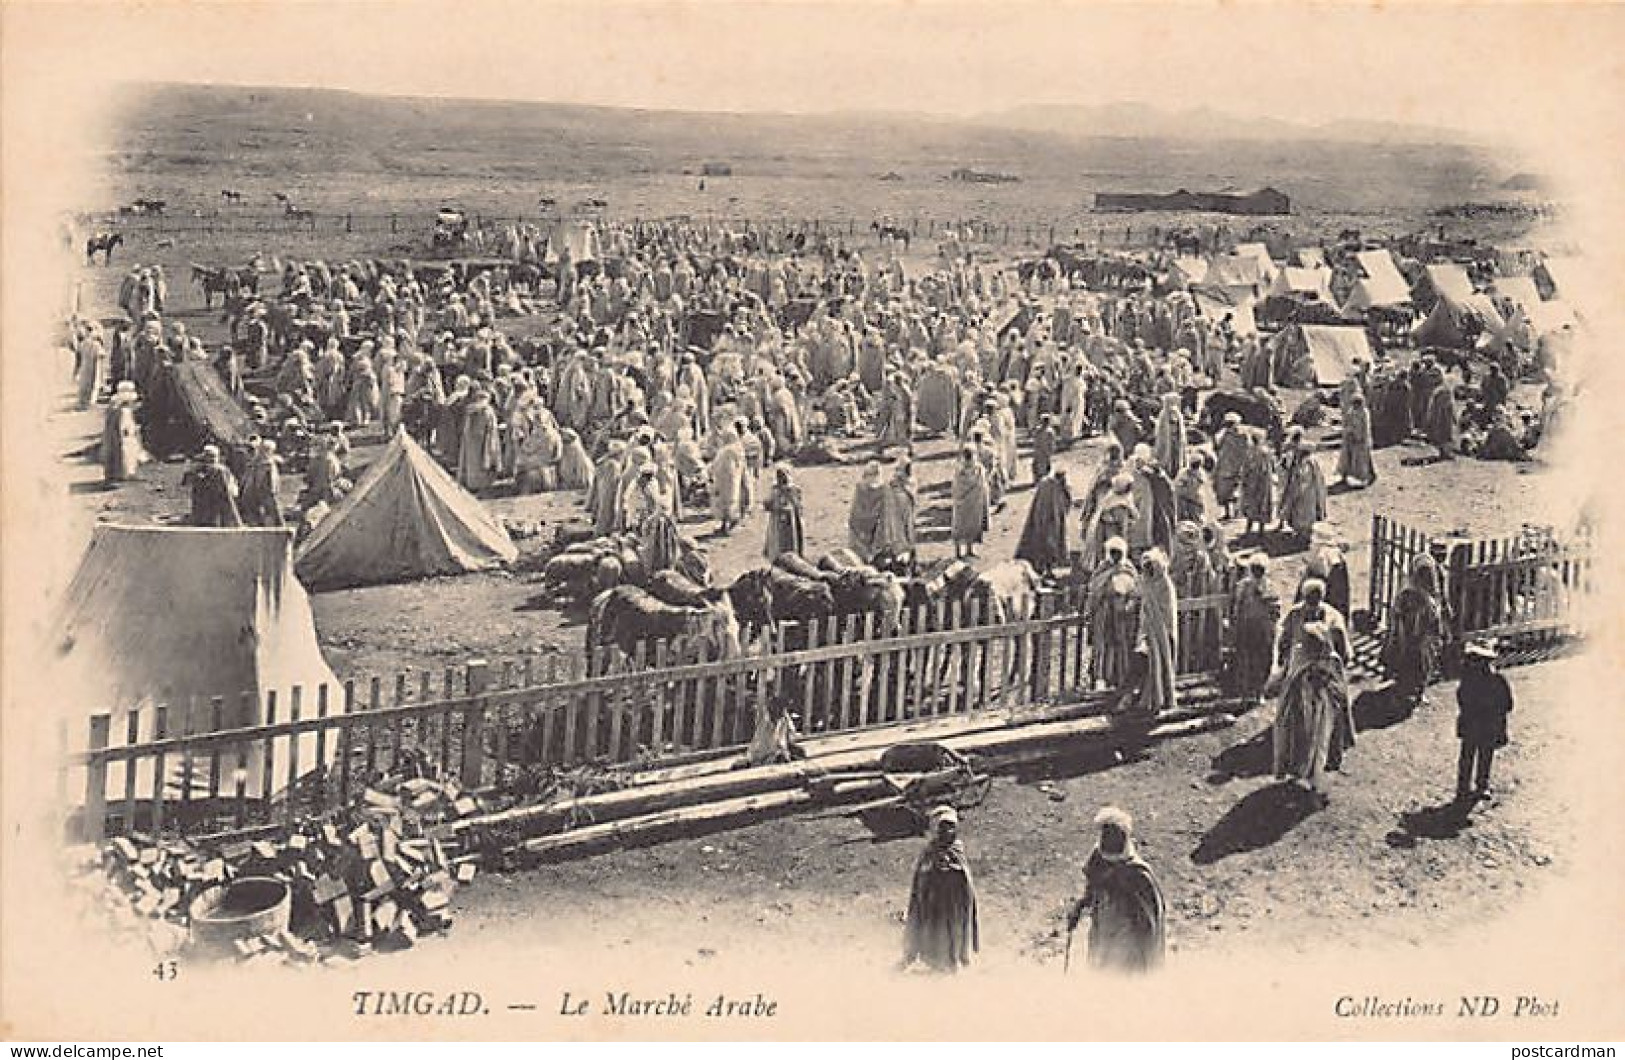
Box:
[60,593,1229,839]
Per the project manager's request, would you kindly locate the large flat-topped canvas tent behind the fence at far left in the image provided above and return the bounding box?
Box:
[46,525,343,793]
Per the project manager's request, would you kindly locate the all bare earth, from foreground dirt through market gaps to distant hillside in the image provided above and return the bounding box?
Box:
[52,89,1575,969]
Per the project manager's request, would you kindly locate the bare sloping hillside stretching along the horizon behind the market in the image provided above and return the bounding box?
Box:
[102,83,1511,219]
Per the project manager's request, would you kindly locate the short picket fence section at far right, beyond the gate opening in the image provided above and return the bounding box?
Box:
[1370,515,1594,642]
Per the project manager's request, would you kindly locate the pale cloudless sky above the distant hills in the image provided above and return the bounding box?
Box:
[5,0,1625,139]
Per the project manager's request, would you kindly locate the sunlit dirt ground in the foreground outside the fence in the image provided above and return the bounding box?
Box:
[380,662,1575,977]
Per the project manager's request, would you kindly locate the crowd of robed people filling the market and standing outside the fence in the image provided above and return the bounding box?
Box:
[68,212,1565,967]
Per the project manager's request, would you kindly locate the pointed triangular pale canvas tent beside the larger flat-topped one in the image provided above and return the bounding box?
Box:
[296,431,518,590]
